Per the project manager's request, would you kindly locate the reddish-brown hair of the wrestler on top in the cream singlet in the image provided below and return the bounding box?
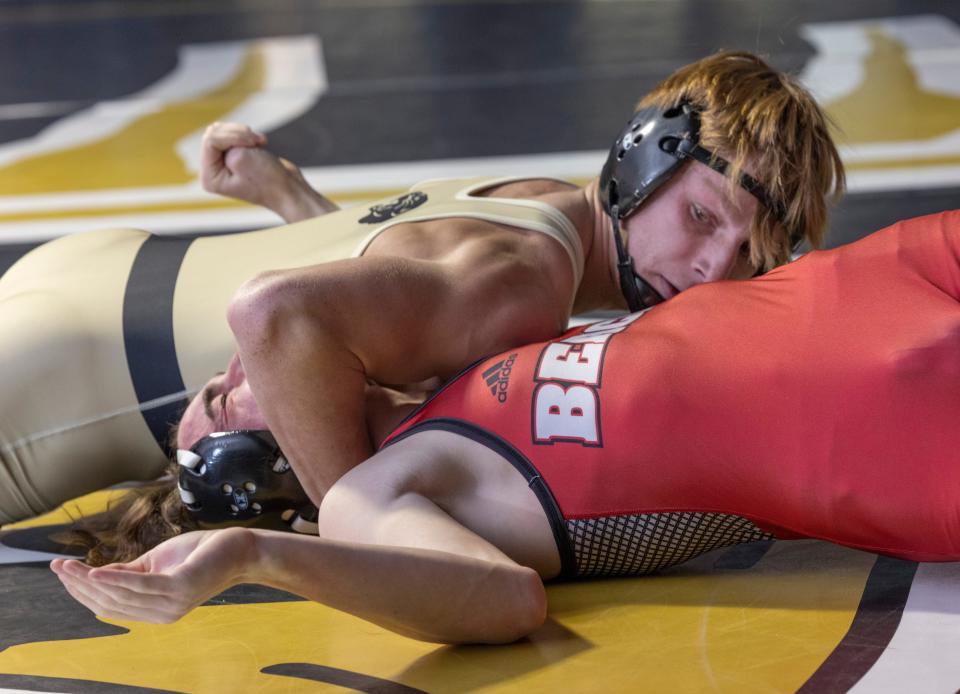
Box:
[637,51,846,269]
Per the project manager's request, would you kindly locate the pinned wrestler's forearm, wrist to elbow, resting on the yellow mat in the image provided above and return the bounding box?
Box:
[243,530,546,643]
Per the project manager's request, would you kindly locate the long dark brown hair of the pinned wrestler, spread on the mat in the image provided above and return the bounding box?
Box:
[54,465,197,566]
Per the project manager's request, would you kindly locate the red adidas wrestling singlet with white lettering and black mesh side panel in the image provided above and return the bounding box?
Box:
[388,211,960,575]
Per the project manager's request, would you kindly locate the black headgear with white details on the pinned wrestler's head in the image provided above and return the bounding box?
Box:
[177,431,315,529]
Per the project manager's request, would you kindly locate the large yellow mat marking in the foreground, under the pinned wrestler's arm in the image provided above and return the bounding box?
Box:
[0,542,874,694]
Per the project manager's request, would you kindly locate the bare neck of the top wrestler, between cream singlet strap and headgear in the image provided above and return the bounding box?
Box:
[573,178,627,314]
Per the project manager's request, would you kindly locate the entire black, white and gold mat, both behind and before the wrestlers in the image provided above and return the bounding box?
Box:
[0,0,960,694]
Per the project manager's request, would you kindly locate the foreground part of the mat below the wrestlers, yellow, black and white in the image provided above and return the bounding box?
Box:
[0,491,960,694]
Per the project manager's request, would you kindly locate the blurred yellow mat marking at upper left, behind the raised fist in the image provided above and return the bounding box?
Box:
[0,48,266,195]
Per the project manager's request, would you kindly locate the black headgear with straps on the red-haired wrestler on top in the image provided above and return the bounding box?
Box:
[599,102,783,311]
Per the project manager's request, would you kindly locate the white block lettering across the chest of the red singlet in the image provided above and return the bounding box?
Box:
[532,311,646,447]
